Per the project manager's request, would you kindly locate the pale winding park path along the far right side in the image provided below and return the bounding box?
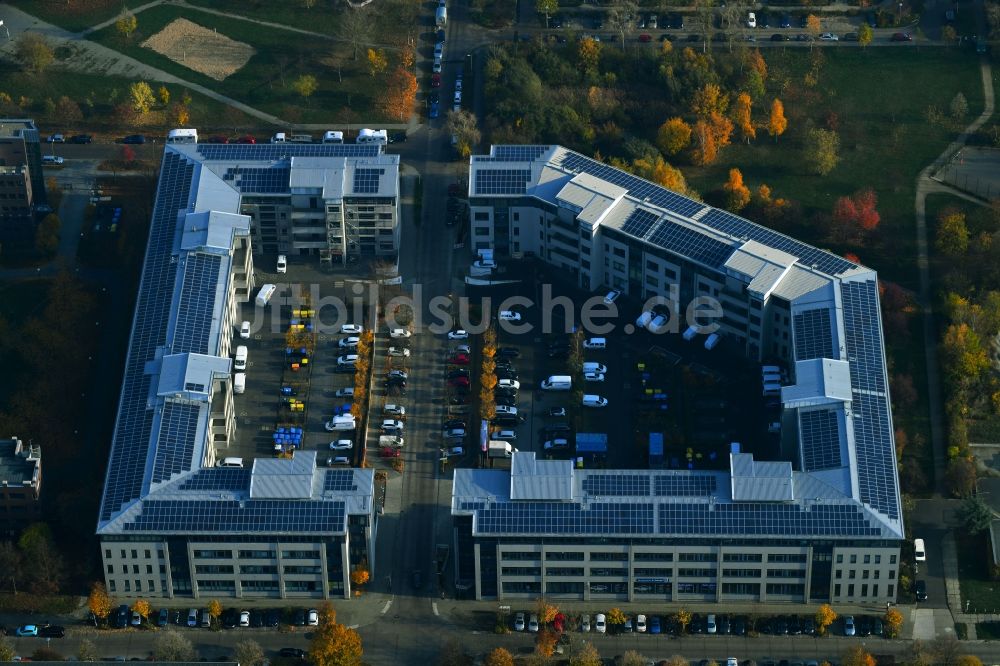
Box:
[914,0,994,492]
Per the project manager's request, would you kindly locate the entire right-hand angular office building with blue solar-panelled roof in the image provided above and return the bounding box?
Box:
[460,146,904,604]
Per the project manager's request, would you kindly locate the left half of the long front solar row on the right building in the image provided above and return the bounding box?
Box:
[463,502,654,534]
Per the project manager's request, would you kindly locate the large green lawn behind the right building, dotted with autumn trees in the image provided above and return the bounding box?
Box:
[684,48,983,290]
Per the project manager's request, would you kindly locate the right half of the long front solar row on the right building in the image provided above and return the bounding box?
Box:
[658,502,880,537]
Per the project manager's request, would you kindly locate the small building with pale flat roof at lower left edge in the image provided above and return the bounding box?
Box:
[0,437,42,534]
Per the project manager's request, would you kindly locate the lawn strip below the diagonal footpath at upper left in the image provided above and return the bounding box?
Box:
[0,68,246,137]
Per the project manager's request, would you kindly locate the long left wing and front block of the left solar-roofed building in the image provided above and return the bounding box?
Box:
[97,144,376,598]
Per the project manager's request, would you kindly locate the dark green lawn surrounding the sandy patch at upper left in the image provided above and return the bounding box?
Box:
[90,5,396,124]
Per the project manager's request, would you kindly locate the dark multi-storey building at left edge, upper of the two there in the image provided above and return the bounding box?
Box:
[0,118,49,247]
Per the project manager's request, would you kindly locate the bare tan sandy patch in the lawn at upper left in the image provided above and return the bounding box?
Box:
[142,18,257,81]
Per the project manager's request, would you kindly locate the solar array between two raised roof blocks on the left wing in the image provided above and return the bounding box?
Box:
[172,252,222,354]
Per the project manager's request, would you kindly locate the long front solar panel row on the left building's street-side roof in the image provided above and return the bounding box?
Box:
[124,499,346,534]
